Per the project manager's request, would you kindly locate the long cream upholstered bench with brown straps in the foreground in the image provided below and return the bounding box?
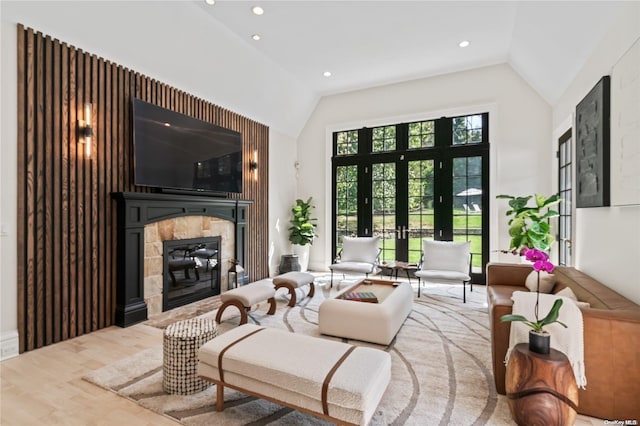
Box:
[198,324,391,425]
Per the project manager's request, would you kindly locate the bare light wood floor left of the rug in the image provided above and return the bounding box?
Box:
[0,325,178,426]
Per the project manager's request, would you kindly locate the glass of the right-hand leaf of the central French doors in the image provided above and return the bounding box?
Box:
[407,160,434,263]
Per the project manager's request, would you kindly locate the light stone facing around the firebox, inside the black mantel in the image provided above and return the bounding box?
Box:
[144,216,235,318]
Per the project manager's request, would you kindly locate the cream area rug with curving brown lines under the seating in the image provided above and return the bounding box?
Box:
[84,285,513,426]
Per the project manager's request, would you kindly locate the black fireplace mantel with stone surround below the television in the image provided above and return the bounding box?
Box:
[112,192,251,327]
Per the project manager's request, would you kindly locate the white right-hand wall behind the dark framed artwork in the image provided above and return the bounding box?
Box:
[553,2,640,303]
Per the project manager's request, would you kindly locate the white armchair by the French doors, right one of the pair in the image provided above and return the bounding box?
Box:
[416,240,473,303]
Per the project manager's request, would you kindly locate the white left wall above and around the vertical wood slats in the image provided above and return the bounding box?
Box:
[0,0,304,359]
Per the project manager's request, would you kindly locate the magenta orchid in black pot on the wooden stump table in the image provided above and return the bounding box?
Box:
[500,248,567,354]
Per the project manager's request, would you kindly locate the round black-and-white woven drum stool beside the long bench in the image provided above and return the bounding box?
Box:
[162,318,218,395]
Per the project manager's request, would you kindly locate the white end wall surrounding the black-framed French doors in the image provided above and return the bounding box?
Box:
[298,65,555,270]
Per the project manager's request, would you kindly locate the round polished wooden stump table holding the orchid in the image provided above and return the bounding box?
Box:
[505,343,578,426]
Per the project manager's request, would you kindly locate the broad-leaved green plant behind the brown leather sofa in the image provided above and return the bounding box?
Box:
[496,194,560,253]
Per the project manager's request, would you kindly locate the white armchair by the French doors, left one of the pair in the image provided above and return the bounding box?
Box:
[329,237,380,287]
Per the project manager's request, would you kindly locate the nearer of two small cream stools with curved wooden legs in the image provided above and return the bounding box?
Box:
[216,280,276,324]
